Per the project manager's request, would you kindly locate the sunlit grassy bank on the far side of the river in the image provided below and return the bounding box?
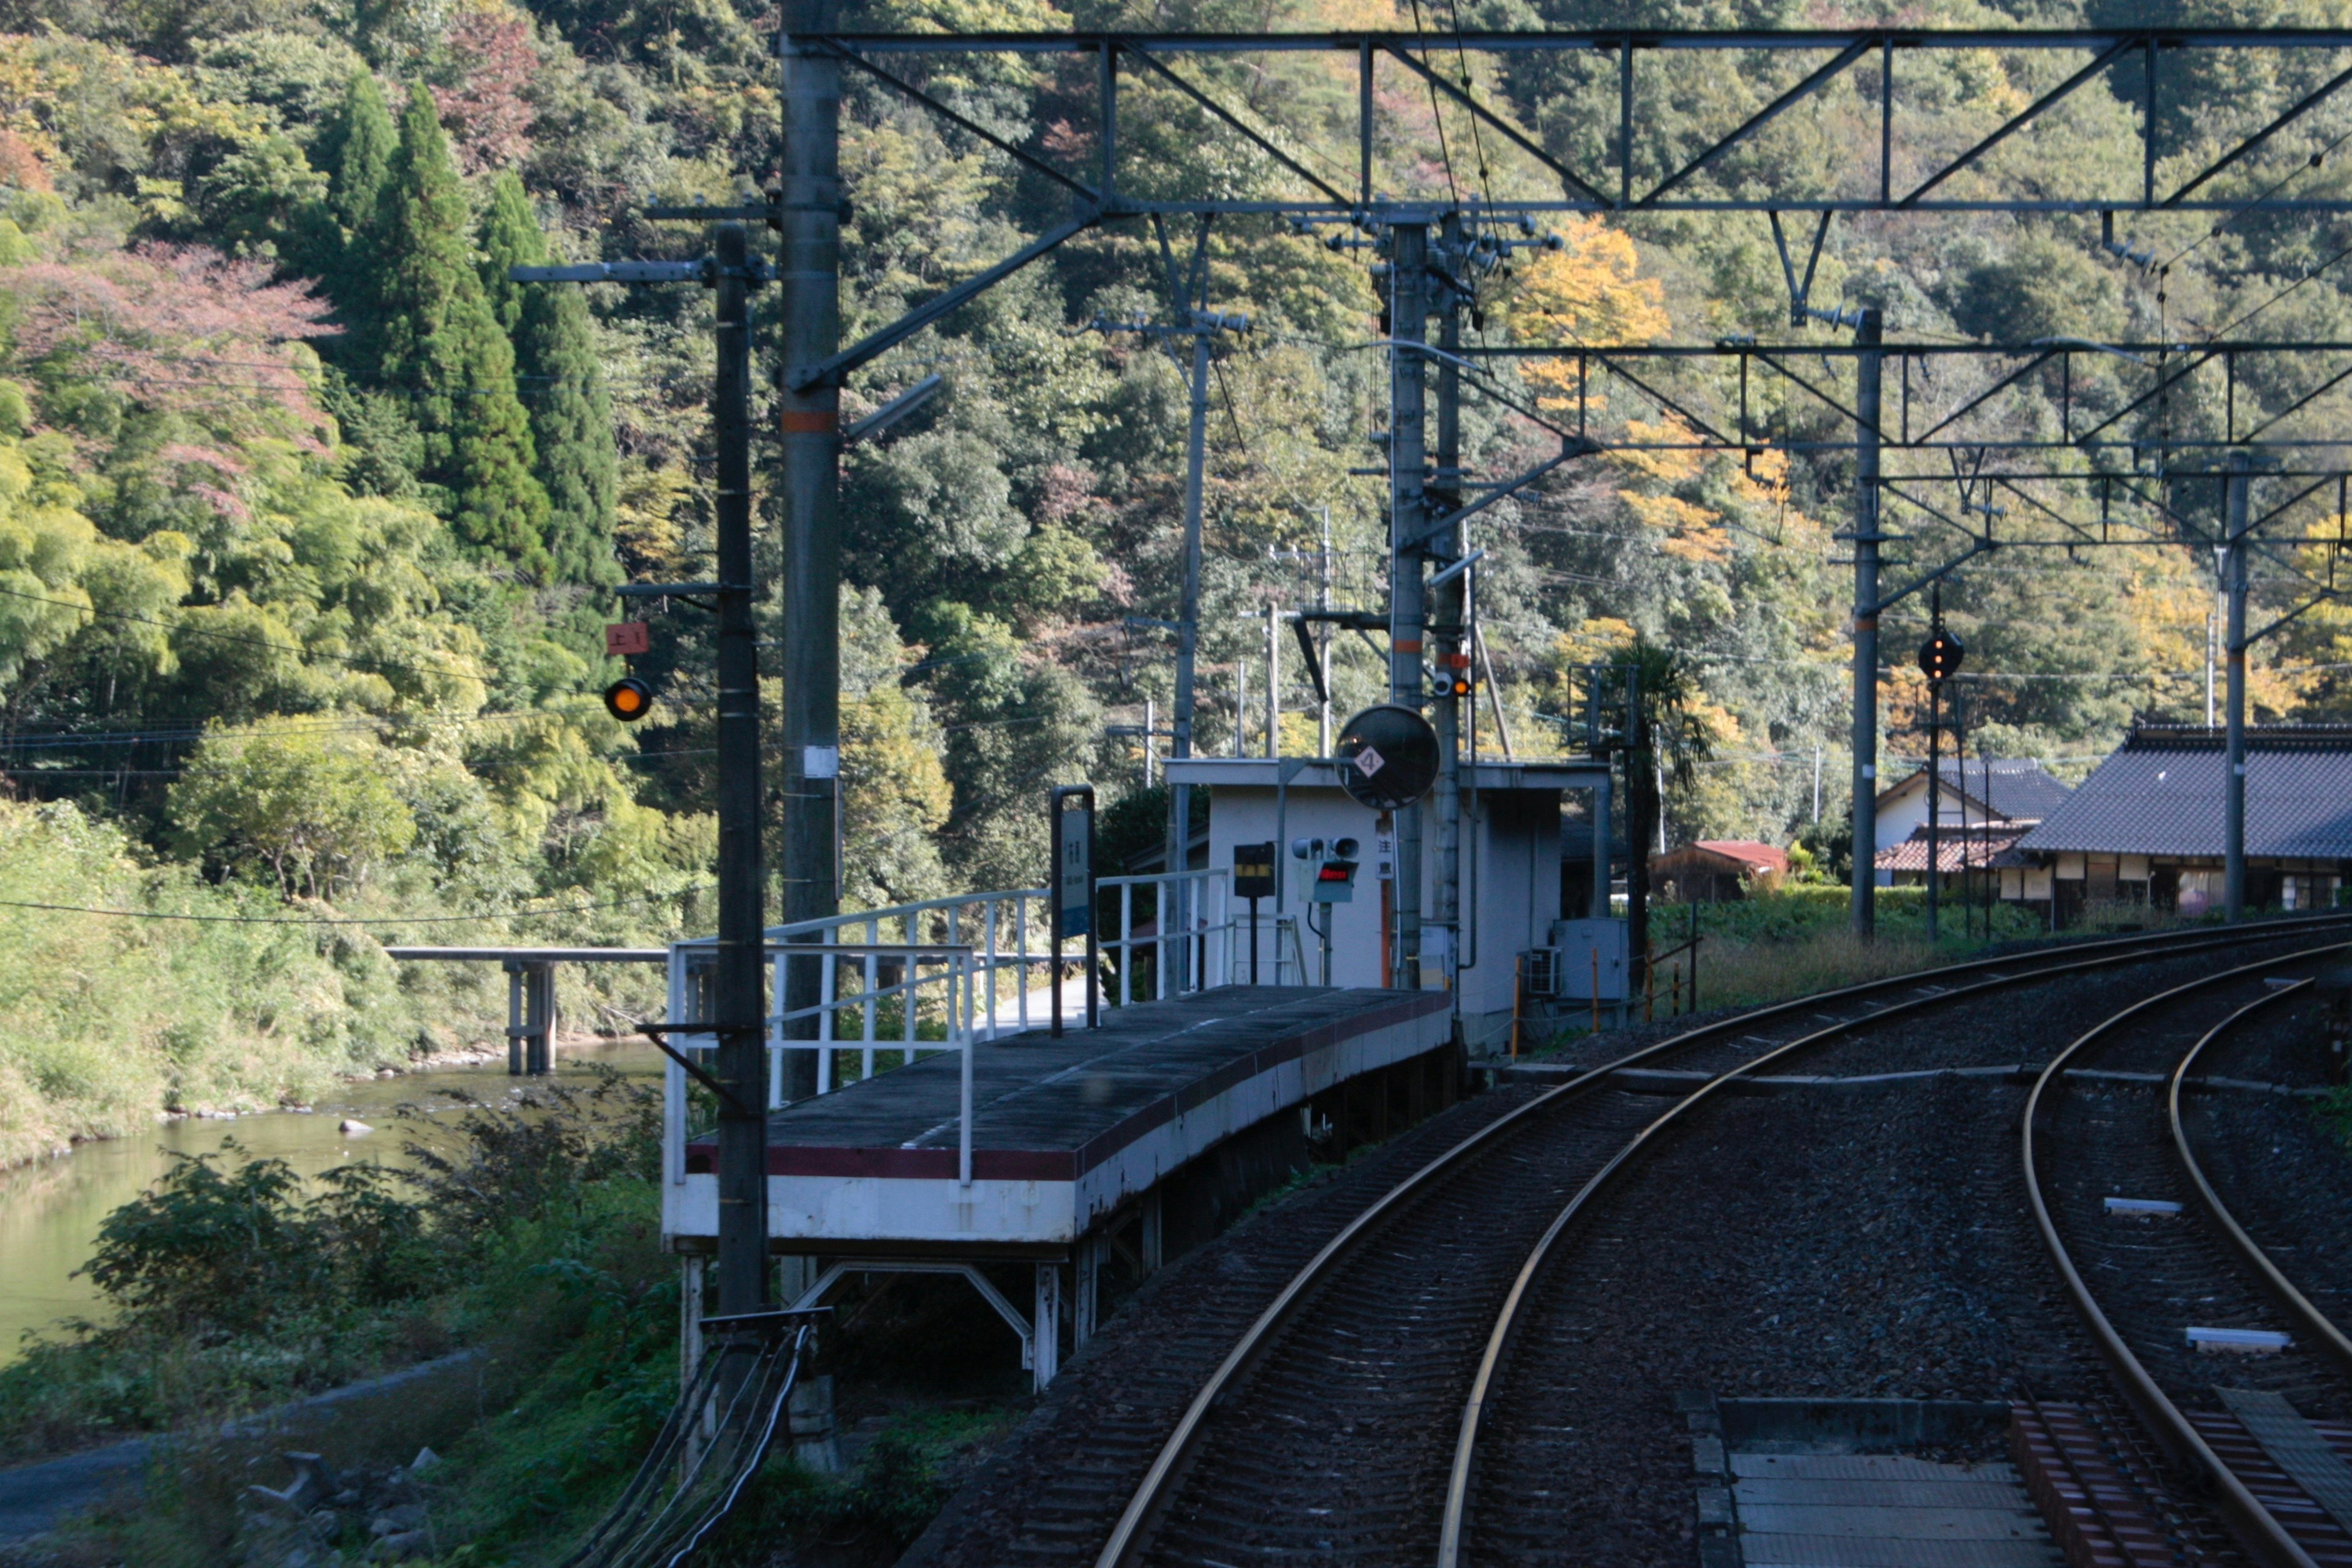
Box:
[0,799,673,1170]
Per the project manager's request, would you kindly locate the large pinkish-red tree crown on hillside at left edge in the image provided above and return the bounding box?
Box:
[0,244,334,451]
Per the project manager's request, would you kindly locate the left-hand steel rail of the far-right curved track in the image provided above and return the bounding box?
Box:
[2018,943,2352,1568]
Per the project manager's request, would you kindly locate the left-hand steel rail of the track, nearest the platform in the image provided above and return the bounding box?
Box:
[1096,914,2352,1568]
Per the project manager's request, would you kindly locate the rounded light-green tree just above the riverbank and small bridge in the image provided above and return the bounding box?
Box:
[169,724,417,898]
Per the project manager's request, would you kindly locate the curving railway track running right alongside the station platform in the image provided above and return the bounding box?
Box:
[1061,917,2340,1568]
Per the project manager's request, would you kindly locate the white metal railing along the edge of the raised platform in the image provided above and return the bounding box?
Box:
[663,870,1313,1183]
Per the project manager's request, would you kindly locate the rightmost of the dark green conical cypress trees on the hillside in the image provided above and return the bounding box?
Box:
[482,169,621,588]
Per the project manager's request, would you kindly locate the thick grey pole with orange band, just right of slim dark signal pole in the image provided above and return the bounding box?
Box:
[776,18,842,1109]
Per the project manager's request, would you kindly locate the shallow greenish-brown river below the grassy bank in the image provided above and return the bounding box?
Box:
[0,1041,661,1366]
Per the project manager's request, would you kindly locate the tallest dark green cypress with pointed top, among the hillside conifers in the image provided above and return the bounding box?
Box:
[367,85,552,571]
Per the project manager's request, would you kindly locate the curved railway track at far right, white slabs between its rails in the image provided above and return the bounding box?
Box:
[2021,943,2352,1568]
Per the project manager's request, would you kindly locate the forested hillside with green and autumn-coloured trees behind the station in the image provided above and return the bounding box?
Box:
[0,0,2352,1159]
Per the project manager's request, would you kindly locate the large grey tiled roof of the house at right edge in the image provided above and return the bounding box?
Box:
[2018,724,2352,861]
